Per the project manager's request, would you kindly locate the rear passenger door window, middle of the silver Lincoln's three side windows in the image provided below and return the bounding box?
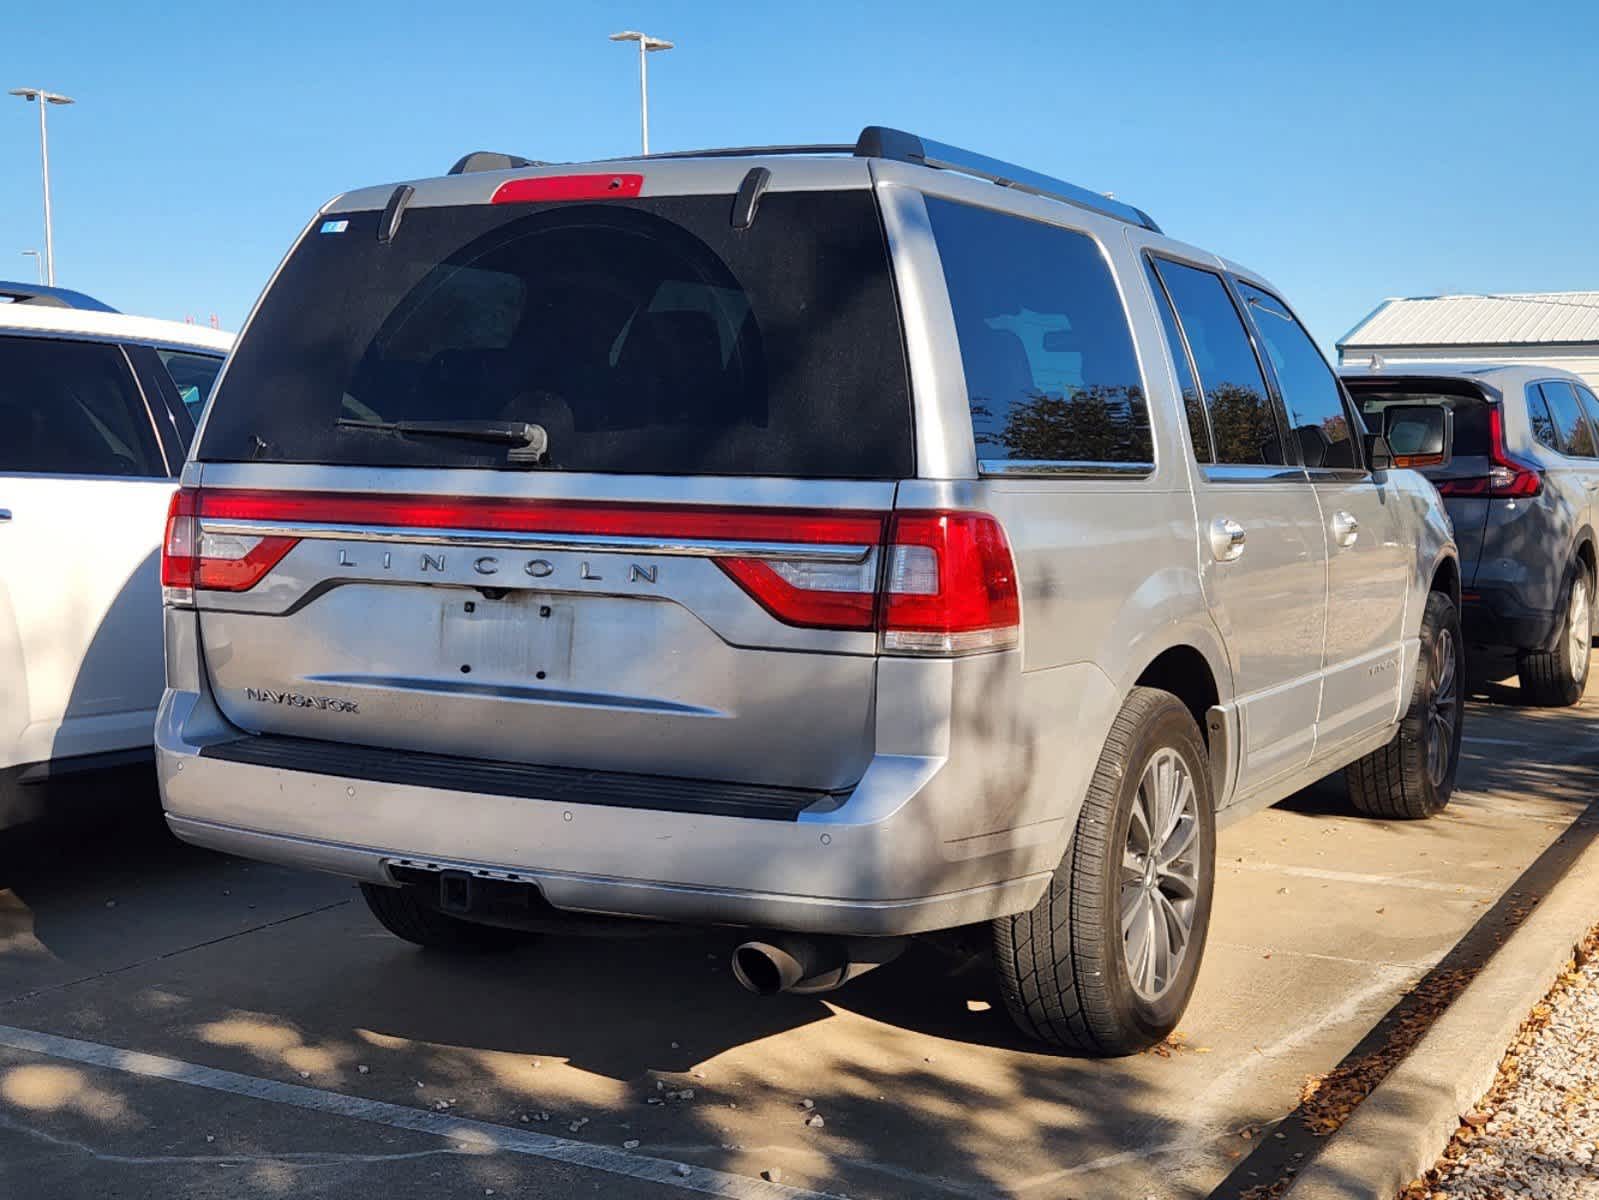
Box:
[1156,259,1289,466]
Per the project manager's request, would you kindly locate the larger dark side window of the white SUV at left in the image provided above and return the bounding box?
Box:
[0,338,168,478]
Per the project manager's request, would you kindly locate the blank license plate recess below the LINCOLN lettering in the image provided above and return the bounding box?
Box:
[440,592,576,683]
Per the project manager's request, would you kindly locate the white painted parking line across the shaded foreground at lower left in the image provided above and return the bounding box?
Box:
[0,1026,827,1200]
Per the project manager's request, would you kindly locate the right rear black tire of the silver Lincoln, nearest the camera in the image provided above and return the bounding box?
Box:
[995,688,1215,1058]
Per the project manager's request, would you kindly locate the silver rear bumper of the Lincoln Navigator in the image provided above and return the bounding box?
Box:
[155,691,1075,936]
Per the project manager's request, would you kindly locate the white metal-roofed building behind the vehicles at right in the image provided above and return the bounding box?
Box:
[1338,291,1599,386]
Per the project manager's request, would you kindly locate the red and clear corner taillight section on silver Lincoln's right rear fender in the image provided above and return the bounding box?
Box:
[881,512,1022,654]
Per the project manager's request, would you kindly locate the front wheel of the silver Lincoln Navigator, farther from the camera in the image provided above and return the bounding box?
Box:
[1343,592,1466,821]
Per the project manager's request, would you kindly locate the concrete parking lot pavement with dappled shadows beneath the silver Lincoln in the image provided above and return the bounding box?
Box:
[0,662,1599,1200]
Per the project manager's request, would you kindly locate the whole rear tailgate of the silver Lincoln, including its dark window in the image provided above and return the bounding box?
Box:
[176,171,913,790]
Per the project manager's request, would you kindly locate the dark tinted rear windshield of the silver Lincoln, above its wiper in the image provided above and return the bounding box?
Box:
[197,190,913,478]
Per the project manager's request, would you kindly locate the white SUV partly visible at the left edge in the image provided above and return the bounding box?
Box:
[0,283,233,826]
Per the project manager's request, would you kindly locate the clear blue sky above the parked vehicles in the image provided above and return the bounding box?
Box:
[0,0,1599,346]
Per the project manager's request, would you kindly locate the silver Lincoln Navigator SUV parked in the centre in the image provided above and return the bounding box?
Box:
[157,128,1463,1054]
